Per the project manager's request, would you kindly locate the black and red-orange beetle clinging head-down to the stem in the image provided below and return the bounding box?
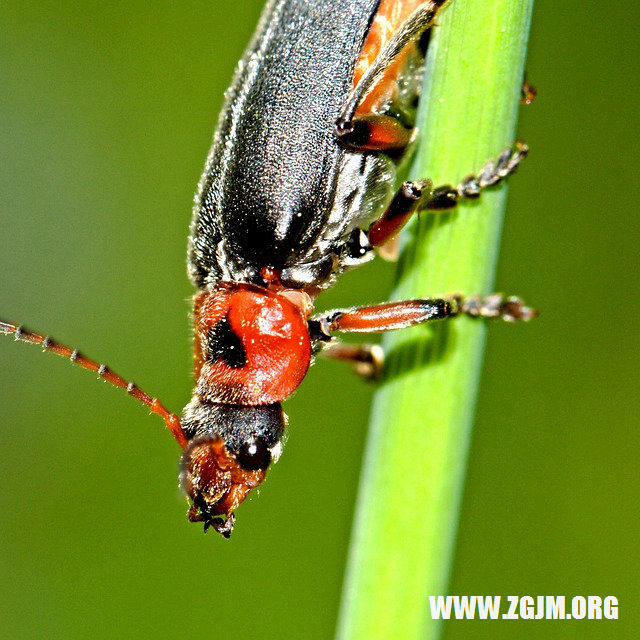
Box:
[0,0,535,537]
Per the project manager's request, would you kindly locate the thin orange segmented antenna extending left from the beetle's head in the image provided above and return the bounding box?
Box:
[0,320,187,449]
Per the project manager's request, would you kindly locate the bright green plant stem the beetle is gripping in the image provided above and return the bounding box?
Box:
[338,0,533,640]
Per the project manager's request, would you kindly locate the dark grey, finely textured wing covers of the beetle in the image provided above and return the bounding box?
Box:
[189,0,388,287]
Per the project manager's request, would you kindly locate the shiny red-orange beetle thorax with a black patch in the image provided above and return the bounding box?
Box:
[194,283,311,405]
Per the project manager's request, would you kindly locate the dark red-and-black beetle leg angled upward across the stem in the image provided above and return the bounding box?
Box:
[367,142,529,247]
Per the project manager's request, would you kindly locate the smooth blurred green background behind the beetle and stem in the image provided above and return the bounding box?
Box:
[0,0,640,640]
